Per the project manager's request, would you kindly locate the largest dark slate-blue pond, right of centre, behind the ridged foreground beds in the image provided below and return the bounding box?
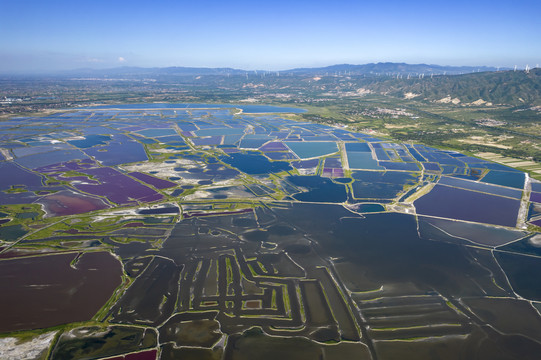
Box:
[274,203,508,296]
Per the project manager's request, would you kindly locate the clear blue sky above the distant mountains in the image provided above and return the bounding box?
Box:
[0,0,541,73]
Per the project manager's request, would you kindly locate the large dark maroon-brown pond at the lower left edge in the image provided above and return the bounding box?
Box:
[0,252,122,332]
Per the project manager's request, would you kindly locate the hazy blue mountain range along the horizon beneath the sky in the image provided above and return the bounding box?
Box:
[57,62,508,77]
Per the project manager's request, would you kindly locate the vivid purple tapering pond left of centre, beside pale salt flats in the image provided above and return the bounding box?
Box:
[74,167,163,205]
